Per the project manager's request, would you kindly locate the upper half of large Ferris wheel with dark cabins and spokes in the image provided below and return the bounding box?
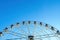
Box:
[0,21,60,40]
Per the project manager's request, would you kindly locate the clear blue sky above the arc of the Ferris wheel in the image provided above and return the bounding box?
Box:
[0,0,60,31]
